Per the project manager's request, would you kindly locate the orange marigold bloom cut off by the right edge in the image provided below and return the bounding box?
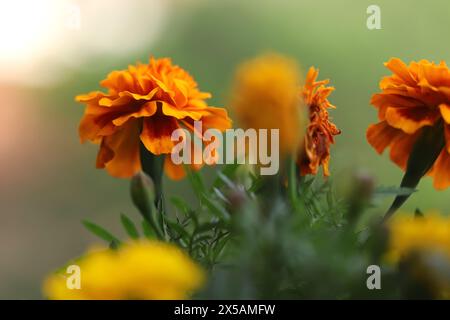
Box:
[367,58,450,189]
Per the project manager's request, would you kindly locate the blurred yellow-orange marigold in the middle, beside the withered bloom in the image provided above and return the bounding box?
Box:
[232,54,302,156]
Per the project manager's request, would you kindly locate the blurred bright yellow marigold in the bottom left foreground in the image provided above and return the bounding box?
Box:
[43,241,204,300]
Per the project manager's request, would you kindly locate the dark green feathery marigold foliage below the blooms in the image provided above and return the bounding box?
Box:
[85,160,438,299]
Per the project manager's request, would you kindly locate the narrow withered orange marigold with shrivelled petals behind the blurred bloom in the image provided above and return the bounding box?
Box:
[297,67,341,176]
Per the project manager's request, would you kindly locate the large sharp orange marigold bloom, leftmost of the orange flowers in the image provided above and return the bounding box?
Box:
[76,57,231,179]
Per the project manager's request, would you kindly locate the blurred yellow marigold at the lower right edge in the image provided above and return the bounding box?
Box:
[386,213,450,298]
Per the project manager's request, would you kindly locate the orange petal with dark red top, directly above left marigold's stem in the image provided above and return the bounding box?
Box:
[140,115,179,155]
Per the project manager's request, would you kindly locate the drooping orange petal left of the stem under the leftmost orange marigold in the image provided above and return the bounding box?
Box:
[99,120,141,178]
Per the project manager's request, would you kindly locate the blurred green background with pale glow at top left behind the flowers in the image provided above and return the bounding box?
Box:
[0,0,450,299]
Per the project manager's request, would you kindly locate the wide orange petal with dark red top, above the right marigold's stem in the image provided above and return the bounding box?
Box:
[386,107,439,134]
